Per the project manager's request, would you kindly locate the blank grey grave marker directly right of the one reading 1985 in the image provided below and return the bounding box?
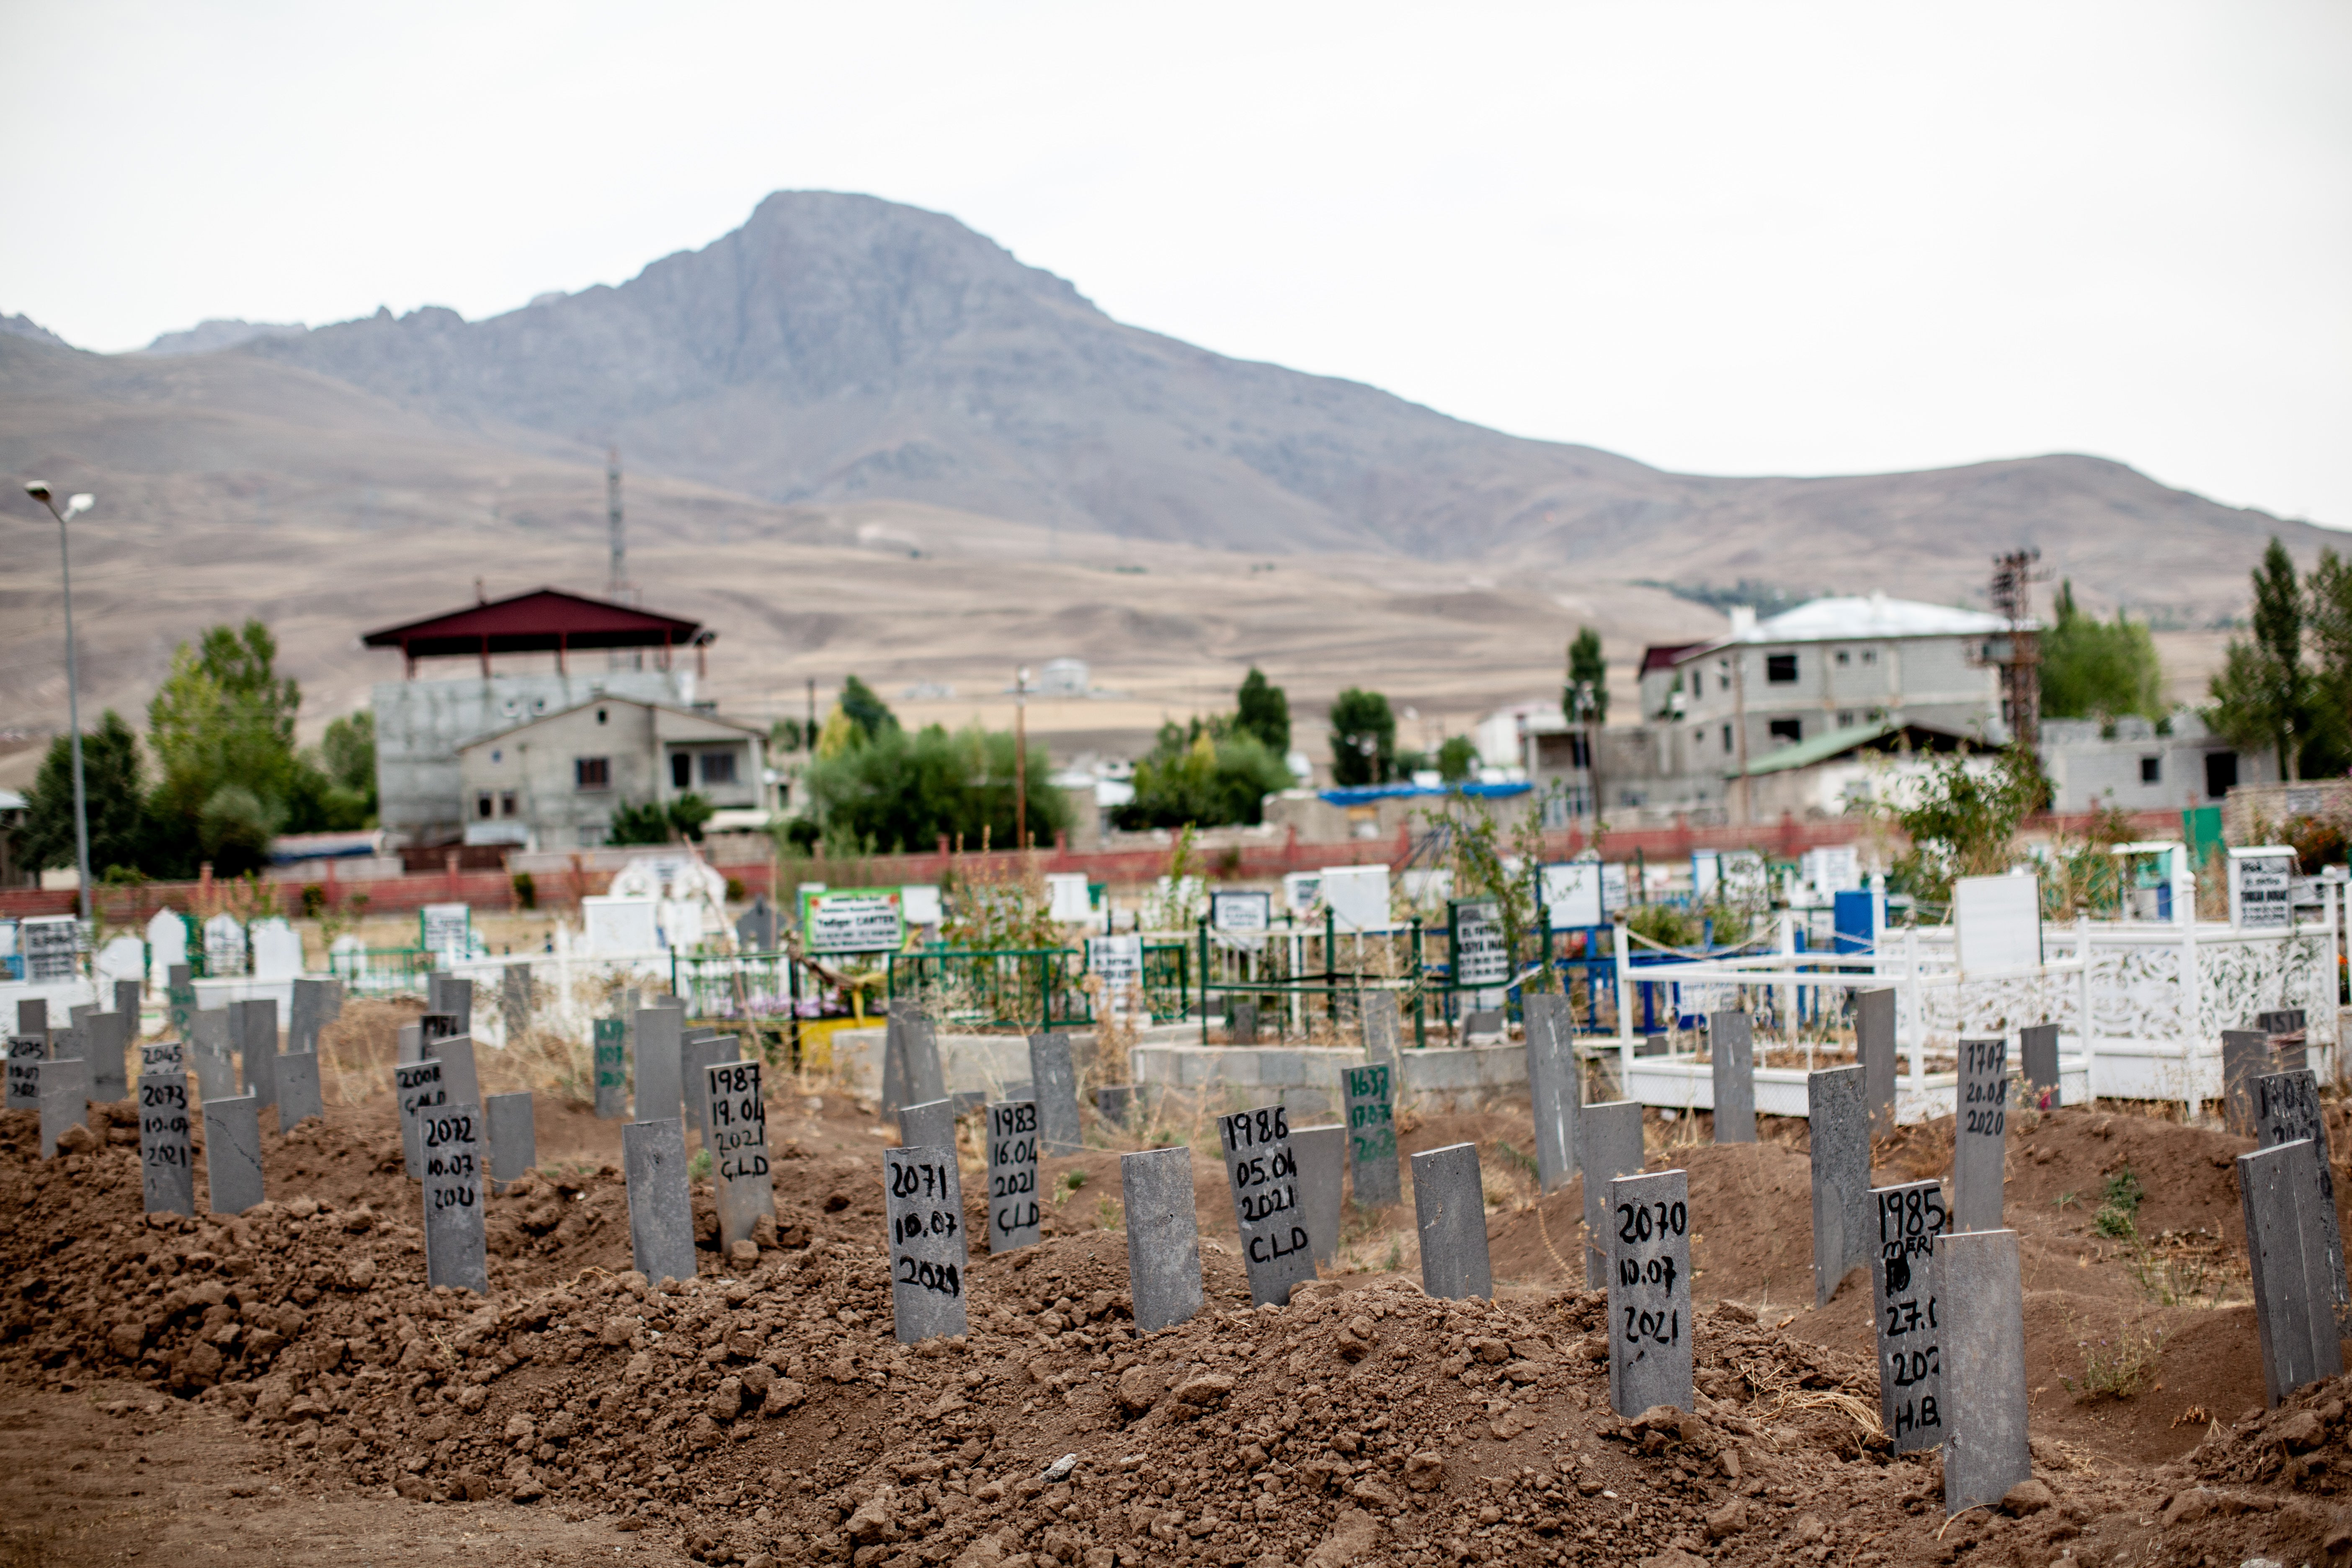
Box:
[1936,1230,2035,1514]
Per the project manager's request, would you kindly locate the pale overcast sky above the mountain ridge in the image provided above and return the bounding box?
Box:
[0,0,2352,526]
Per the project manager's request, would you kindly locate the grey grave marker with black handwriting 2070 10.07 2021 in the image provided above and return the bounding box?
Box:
[1602,1171,1691,1415]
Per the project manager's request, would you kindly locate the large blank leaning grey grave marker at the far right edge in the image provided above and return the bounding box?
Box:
[2237,1138,2343,1406]
